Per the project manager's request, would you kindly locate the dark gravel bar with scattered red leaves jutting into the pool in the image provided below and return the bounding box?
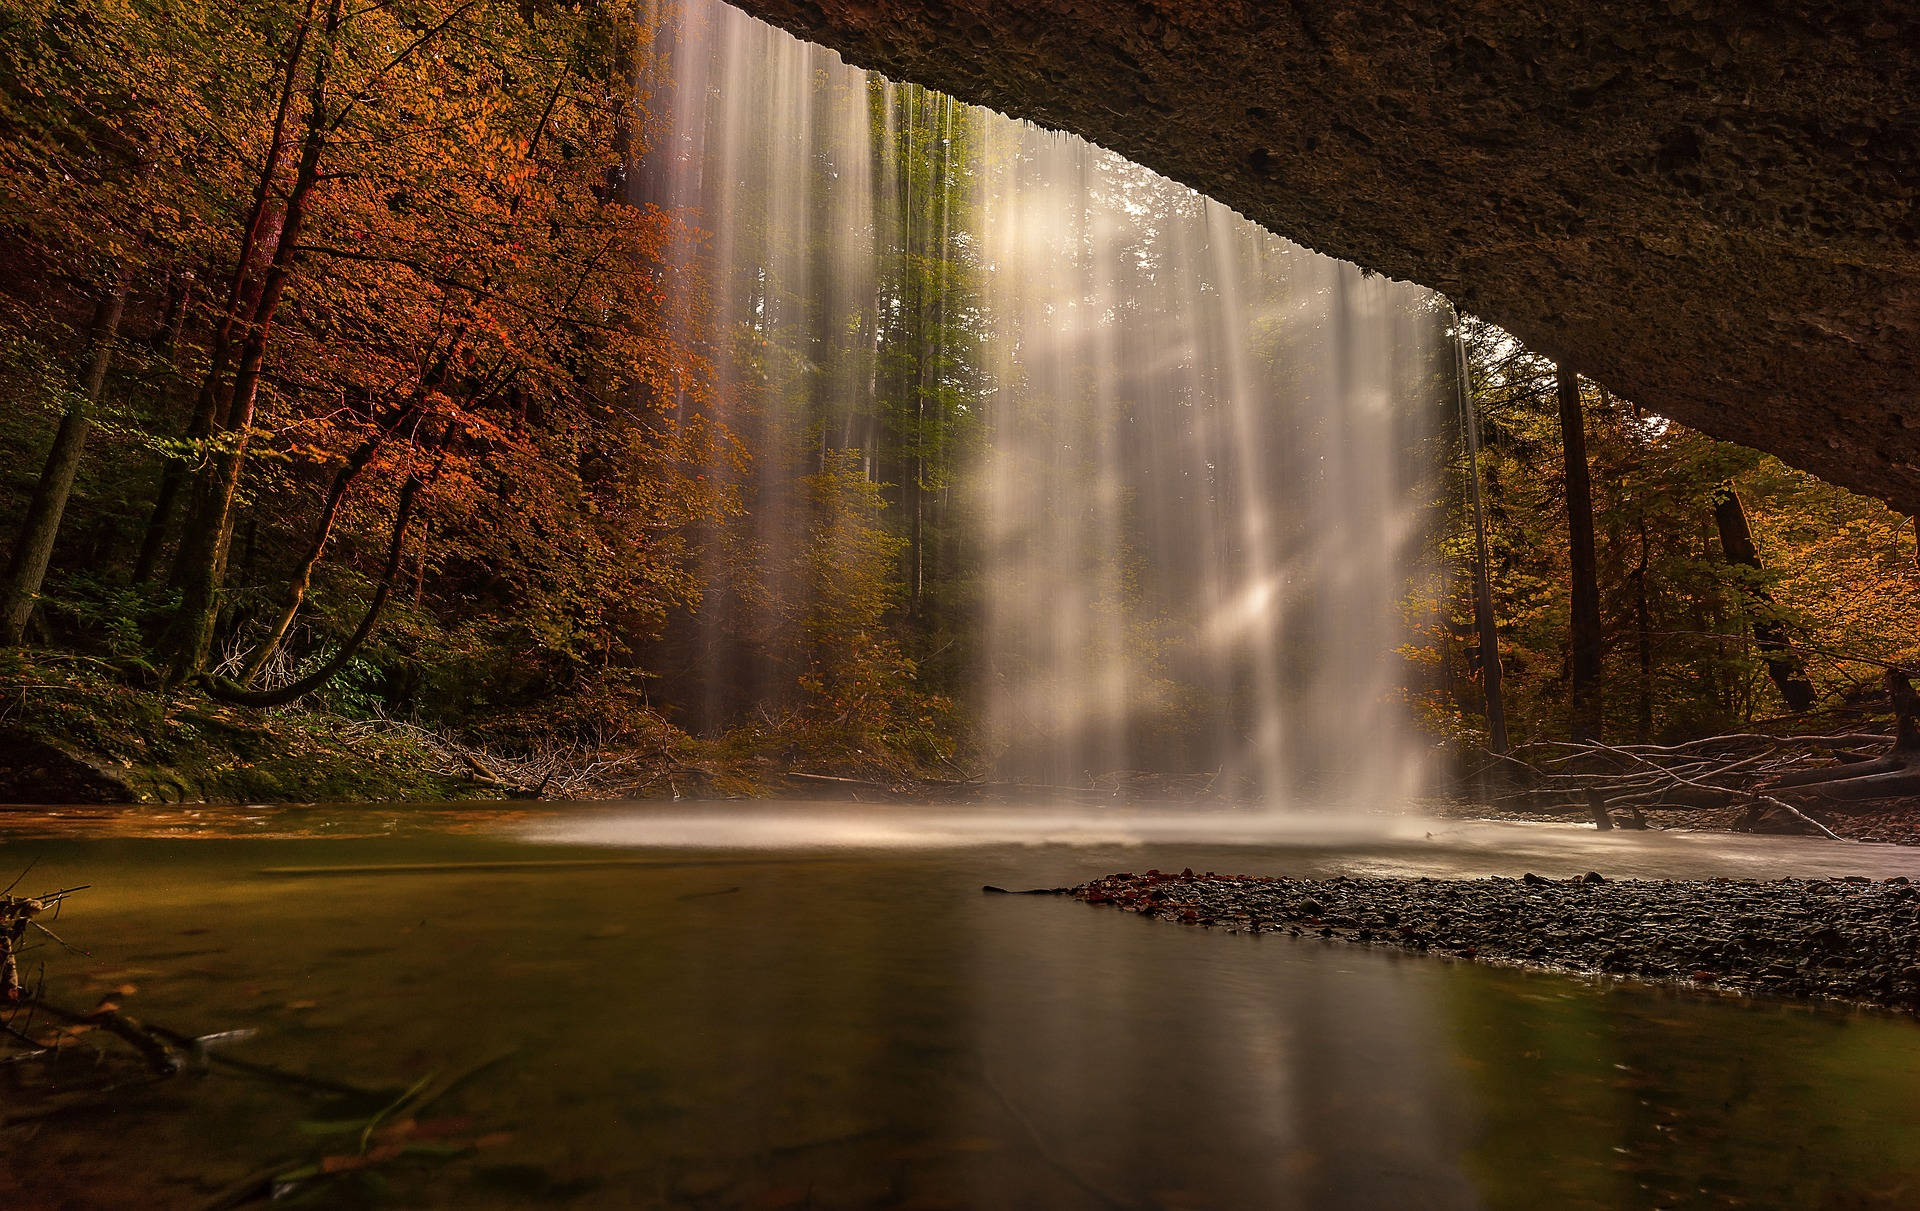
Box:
[1068,871,1920,1013]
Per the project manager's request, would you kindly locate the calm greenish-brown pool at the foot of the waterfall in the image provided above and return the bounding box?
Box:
[0,804,1920,1211]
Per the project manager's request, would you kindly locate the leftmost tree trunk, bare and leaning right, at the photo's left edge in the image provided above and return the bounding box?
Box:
[0,269,129,647]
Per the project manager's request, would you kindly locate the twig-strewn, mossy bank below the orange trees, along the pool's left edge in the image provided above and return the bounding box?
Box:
[0,653,968,804]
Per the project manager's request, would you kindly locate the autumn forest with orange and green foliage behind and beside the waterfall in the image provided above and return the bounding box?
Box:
[0,0,1920,798]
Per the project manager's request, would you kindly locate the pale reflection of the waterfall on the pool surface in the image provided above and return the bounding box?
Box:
[972,906,1476,1207]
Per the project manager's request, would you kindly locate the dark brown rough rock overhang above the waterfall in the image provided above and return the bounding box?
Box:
[735,0,1920,511]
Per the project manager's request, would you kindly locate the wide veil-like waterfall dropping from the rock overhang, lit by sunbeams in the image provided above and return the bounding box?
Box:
[641,0,1446,806]
